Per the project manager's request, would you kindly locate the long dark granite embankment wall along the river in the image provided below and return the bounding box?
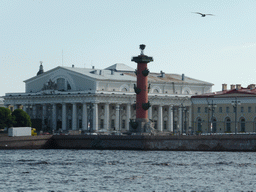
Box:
[0,135,256,151]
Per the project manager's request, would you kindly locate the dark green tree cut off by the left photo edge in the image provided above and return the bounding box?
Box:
[0,107,14,129]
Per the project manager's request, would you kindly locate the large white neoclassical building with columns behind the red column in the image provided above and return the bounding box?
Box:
[4,63,213,132]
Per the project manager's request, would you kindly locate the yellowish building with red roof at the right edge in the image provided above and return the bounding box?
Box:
[191,84,256,133]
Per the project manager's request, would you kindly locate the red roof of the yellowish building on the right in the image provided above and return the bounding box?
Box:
[191,86,256,98]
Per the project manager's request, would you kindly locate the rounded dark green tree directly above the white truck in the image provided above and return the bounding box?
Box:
[12,109,31,127]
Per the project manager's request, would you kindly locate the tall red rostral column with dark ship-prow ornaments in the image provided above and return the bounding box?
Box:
[132,44,153,132]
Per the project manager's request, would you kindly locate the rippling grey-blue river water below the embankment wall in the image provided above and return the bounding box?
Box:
[0,150,256,192]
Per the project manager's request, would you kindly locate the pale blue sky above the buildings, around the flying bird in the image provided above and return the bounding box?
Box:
[0,0,256,96]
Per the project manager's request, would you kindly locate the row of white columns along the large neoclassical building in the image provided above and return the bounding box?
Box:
[6,102,192,133]
